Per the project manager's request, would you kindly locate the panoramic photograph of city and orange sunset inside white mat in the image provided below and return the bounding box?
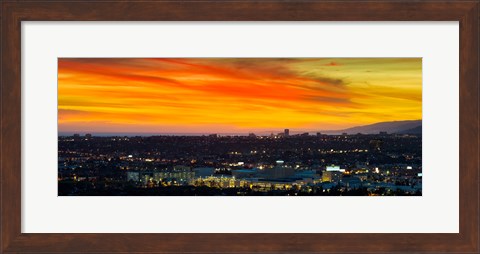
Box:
[57,58,422,196]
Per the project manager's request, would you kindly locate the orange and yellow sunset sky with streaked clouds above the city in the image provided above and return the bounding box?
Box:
[58,58,422,134]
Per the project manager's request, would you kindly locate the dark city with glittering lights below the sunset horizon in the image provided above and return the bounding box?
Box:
[58,132,422,196]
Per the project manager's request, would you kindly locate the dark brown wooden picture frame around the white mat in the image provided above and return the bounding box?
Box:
[0,0,480,253]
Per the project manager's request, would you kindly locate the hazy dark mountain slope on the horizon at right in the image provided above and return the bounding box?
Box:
[322,120,422,134]
